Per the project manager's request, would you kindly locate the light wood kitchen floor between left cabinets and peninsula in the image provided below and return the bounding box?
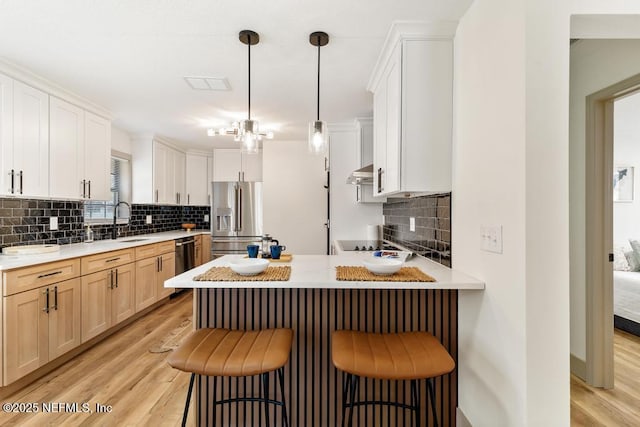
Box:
[0,292,195,427]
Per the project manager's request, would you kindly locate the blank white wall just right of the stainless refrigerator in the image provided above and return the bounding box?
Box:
[262,140,327,256]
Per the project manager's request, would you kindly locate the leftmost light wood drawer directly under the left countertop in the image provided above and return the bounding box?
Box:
[2,258,80,296]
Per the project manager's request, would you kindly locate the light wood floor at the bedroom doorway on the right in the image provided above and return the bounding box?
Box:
[571,329,640,427]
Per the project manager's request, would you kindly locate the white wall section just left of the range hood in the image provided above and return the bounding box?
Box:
[329,125,382,240]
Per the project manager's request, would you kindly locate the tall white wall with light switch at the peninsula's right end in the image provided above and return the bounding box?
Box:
[451,0,526,426]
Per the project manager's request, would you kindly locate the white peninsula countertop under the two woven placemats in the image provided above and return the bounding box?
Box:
[164,253,484,290]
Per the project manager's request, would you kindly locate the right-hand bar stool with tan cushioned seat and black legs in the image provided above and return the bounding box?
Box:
[331,330,455,426]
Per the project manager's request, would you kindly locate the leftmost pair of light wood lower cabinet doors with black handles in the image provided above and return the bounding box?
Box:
[3,278,81,385]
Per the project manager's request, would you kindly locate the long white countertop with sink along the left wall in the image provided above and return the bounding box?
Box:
[0,230,211,271]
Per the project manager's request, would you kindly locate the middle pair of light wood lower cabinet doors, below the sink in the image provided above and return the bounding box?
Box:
[82,263,135,342]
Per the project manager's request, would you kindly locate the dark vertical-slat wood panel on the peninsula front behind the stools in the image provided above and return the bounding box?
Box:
[197,288,458,427]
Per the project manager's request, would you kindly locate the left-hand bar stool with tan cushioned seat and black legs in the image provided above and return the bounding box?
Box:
[167,328,293,427]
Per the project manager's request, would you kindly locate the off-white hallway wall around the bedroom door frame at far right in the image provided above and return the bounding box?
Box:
[569,40,640,360]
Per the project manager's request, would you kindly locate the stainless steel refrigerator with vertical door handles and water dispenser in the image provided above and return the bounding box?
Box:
[211,182,262,258]
